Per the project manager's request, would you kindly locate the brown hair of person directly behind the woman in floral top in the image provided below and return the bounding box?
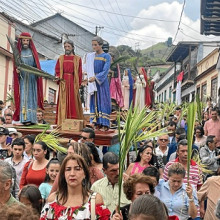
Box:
[68,142,92,167]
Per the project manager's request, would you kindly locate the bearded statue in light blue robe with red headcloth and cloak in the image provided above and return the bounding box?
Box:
[13,33,43,124]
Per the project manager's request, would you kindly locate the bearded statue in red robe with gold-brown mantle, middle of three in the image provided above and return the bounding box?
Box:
[55,40,83,125]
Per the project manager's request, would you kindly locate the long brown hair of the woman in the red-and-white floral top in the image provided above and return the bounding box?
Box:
[58,154,91,205]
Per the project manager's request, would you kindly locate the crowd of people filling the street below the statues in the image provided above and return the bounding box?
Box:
[0,100,220,220]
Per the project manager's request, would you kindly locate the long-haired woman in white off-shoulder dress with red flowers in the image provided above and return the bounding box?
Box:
[40,154,111,220]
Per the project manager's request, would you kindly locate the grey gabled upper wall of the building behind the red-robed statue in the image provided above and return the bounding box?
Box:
[31,13,95,56]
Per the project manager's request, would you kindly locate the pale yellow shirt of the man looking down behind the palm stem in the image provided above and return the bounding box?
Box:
[91,177,131,212]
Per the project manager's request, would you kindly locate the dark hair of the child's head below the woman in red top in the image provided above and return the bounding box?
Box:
[19,185,42,214]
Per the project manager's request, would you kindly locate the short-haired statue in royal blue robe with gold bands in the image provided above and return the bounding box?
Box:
[87,37,111,131]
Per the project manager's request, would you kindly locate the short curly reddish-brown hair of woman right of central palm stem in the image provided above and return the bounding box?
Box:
[123,173,155,200]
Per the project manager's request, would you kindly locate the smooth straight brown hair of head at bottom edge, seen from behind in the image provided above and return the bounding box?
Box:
[129,195,168,220]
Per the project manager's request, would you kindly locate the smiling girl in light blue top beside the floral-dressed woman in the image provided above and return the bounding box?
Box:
[39,158,60,202]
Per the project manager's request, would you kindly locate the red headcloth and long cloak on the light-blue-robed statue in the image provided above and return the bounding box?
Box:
[13,32,44,121]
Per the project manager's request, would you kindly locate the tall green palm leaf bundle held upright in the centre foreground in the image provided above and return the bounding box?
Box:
[117,105,165,211]
